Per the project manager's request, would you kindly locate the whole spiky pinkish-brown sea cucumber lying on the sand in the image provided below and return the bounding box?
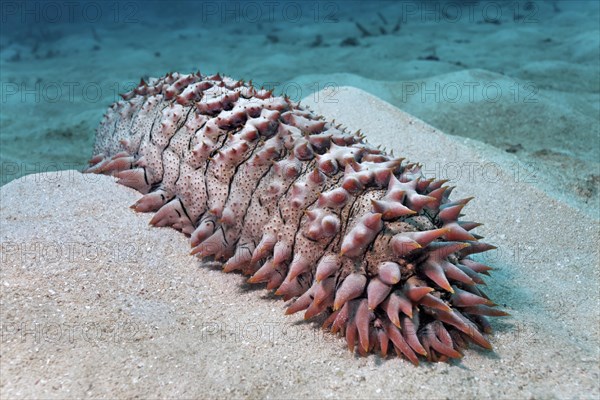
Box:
[88,73,506,364]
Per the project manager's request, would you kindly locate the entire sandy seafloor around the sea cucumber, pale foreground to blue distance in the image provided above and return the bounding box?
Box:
[0,0,600,398]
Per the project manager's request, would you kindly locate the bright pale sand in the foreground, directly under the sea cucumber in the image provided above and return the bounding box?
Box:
[0,88,600,399]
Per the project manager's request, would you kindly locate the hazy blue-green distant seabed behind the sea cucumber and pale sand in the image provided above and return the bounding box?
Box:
[0,0,600,216]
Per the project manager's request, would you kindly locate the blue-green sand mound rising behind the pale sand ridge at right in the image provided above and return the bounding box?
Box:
[295,72,600,216]
